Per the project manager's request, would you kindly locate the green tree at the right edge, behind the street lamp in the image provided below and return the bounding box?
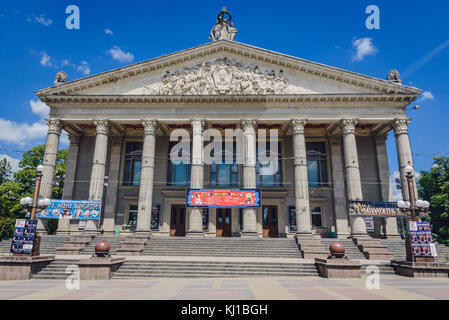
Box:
[418,157,449,244]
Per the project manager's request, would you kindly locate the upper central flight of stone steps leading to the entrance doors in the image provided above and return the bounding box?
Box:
[141,237,301,258]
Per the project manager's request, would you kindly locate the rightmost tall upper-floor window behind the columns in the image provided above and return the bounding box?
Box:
[306,142,328,187]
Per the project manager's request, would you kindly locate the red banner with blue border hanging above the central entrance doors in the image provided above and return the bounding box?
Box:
[186,189,261,208]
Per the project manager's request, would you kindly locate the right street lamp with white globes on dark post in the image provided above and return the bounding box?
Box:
[397,166,430,262]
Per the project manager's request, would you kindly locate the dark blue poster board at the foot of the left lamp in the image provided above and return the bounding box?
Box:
[11,219,37,254]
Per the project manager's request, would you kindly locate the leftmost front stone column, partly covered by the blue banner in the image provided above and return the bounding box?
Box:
[37,119,62,234]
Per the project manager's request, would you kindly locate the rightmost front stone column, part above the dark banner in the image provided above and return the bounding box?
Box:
[393,119,418,200]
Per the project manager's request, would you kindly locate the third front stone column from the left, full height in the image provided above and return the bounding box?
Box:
[136,120,157,234]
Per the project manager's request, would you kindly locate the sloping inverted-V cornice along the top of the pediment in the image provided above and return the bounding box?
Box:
[36,40,422,98]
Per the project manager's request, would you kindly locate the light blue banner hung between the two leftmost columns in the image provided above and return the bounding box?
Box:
[27,199,101,220]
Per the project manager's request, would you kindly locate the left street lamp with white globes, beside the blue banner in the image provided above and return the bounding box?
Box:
[20,165,51,256]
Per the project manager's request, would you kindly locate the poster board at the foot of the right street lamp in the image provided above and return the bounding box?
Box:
[409,221,437,257]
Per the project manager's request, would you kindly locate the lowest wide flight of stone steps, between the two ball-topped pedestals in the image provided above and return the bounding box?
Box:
[113,261,318,279]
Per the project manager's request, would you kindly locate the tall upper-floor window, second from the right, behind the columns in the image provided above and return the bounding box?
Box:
[256,141,282,187]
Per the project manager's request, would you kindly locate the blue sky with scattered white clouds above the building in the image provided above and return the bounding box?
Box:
[0,0,449,198]
